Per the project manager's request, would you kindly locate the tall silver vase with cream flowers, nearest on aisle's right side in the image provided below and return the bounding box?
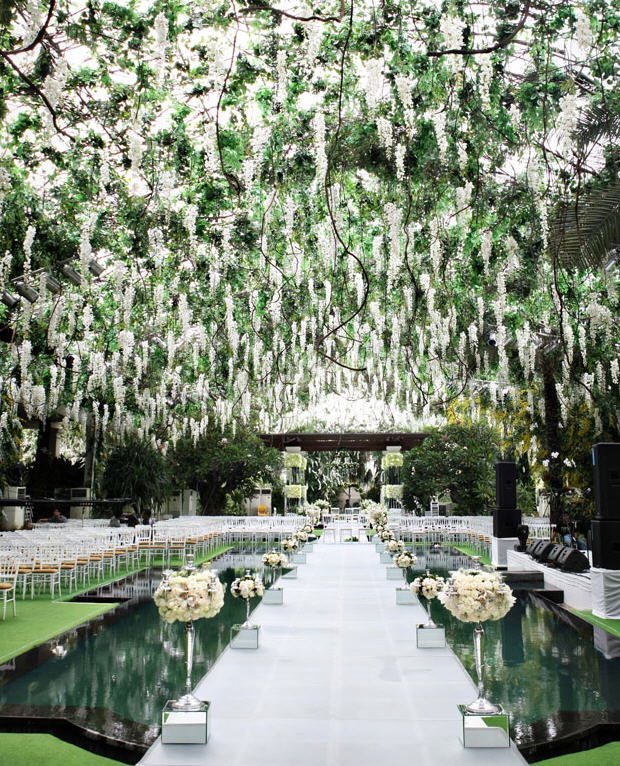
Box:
[437,569,515,715]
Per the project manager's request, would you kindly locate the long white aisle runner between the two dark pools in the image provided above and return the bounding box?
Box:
[141,543,525,766]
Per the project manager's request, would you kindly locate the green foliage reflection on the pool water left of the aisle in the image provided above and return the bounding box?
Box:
[0,569,257,725]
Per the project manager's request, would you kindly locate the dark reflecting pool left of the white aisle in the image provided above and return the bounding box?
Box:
[0,562,258,744]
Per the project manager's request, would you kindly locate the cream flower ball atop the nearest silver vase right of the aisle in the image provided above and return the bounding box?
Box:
[437,569,515,622]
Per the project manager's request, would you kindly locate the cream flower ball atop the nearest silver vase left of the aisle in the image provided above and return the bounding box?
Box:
[153,569,224,622]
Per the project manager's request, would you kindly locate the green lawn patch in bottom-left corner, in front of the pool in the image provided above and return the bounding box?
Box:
[0,734,120,766]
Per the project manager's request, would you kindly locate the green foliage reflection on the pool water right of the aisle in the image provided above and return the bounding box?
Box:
[433,584,620,744]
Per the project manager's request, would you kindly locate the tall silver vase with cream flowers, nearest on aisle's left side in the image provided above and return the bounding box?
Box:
[153,560,224,711]
